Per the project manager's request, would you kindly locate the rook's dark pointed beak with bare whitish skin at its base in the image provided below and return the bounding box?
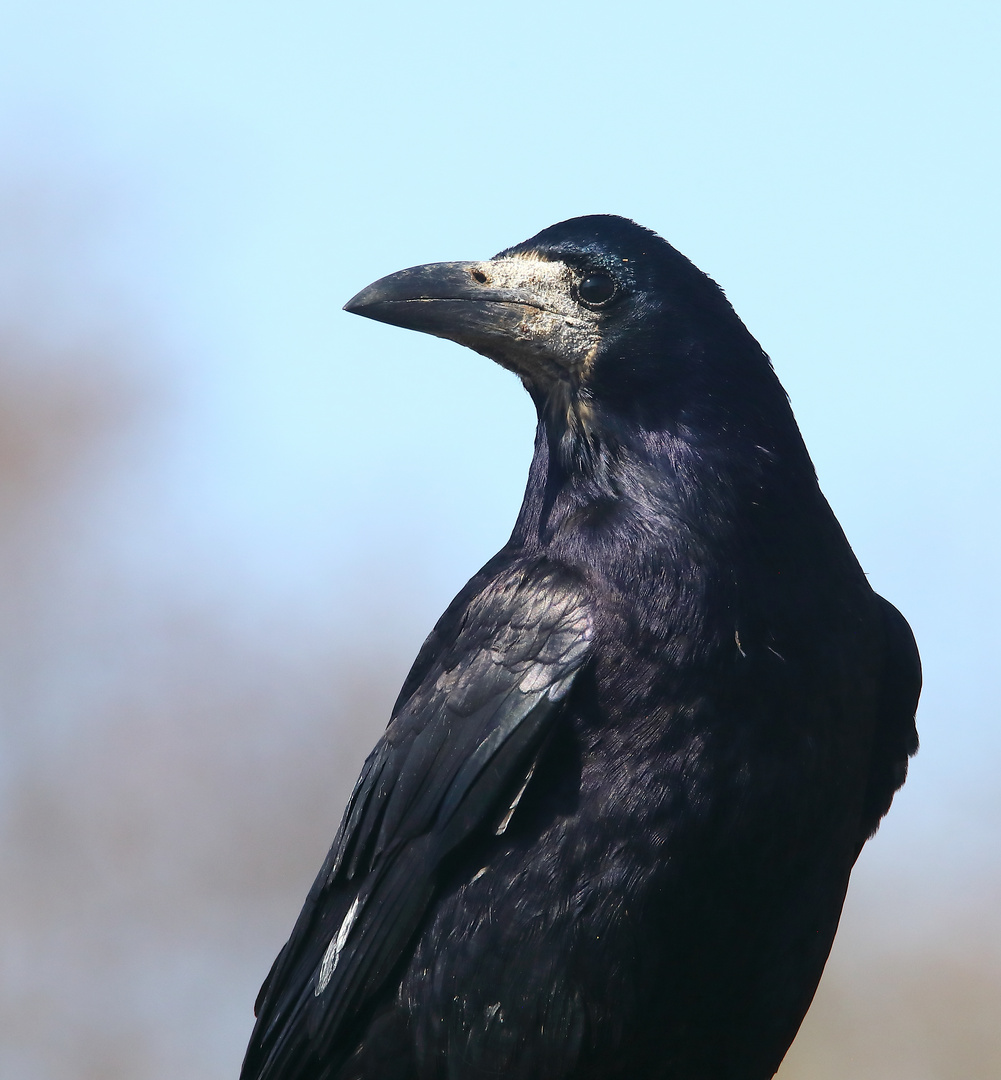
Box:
[344,257,590,387]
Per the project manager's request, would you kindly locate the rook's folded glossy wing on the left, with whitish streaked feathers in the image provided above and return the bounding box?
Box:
[242,562,593,1080]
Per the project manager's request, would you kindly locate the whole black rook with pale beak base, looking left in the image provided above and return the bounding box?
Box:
[242,216,920,1080]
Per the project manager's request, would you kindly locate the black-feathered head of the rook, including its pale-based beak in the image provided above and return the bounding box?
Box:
[344,215,767,410]
